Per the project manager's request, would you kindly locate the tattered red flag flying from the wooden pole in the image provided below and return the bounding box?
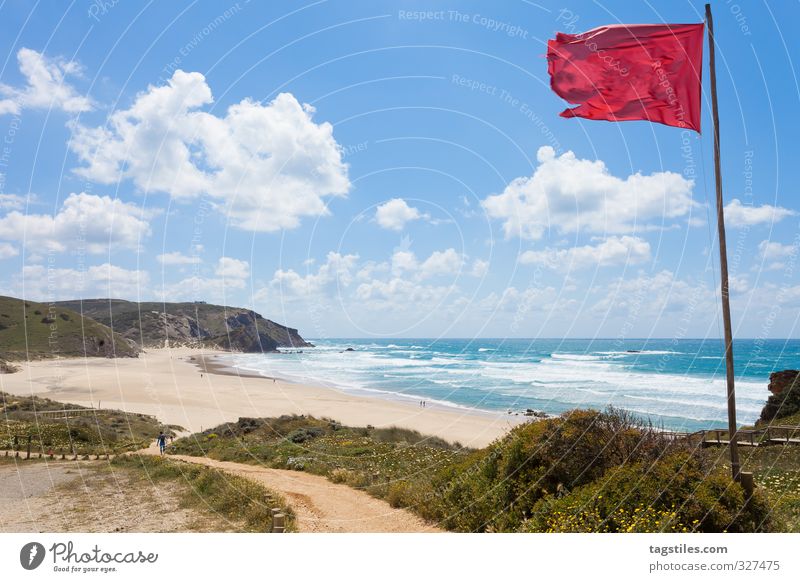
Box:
[547,24,703,133]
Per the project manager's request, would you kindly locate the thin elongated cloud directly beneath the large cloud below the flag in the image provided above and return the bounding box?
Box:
[519,236,650,269]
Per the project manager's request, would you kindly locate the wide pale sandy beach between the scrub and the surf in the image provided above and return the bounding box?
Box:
[0,348,524,447]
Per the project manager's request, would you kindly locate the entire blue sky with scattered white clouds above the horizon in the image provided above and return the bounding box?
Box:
[0,0,800,340]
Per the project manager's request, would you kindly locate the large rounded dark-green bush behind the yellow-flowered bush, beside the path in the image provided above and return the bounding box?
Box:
[423,409,677,531]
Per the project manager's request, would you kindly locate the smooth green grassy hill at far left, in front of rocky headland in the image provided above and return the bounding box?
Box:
[0,297,139,360]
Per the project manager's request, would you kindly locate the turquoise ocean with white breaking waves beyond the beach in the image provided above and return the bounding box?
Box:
[226,339,800,431]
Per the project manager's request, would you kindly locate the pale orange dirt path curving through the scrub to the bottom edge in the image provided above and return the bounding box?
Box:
[142,447,442,533]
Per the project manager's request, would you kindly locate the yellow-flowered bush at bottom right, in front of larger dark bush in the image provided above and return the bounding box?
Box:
[521,452,771,533]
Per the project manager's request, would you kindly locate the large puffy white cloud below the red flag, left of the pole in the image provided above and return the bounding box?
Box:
[482,146,695,240]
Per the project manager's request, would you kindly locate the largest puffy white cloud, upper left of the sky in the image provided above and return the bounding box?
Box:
[70,70,350,231]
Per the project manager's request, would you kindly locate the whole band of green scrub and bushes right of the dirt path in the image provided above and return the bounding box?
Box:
[170,409,780,532]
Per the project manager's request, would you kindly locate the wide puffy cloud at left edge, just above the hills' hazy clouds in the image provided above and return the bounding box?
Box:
[0,192,155,254]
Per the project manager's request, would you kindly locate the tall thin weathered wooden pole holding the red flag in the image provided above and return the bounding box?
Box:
[706,4,741,481]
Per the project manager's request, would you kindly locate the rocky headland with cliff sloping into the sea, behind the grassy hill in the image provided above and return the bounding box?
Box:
[58,299,311,352]
